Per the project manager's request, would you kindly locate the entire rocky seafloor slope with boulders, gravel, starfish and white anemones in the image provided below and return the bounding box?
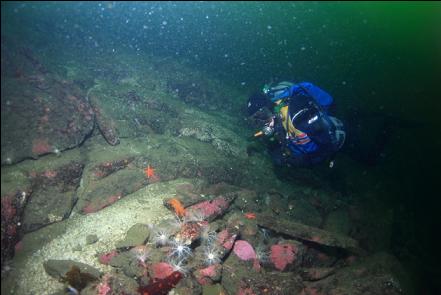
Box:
[1,42,407,295]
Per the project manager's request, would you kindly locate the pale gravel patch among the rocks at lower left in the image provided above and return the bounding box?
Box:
[2,181,182,295]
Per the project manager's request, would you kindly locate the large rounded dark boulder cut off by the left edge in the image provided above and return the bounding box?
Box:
[1,39,94,165]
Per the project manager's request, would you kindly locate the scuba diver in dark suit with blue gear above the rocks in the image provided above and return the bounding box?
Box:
[247,81,346,167]
